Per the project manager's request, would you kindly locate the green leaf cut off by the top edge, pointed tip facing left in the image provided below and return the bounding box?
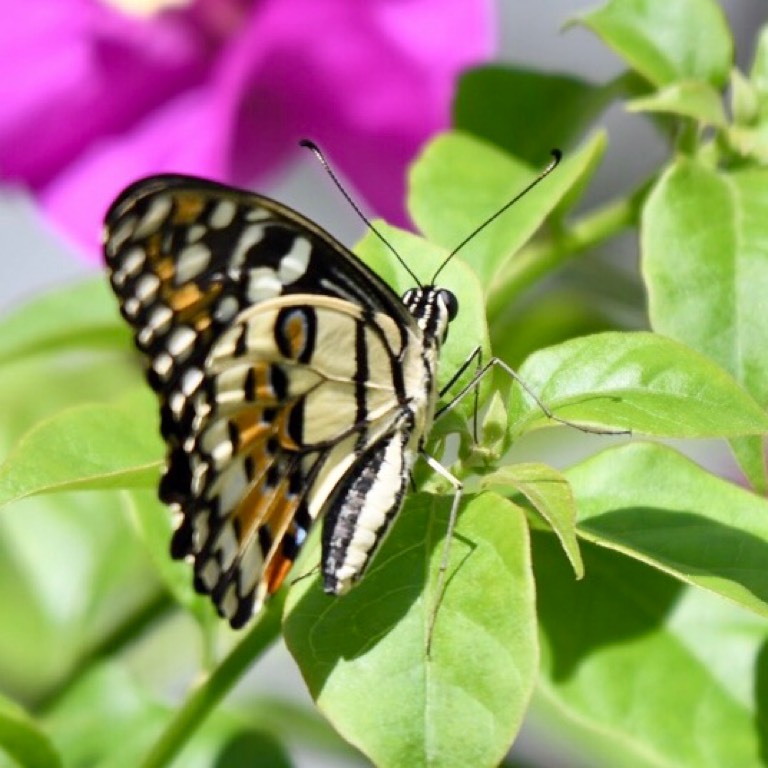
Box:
[578,0,733,88]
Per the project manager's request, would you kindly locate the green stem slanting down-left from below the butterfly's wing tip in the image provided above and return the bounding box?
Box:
[141,589,287,768]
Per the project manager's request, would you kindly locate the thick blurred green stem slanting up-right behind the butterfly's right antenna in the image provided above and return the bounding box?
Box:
[487,195,647,325]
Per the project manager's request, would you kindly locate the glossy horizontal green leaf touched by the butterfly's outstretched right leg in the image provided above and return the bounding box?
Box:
[509,332,768,437]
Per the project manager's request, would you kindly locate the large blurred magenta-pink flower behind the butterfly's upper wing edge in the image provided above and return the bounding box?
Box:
[0,0,493,257]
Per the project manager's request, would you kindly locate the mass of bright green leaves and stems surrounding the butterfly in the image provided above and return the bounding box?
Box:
[0,0,768,768]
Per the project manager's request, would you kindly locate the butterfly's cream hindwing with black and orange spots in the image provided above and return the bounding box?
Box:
[166,295,414,620]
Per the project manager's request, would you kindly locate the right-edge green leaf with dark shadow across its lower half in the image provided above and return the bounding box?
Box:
[566,443,768,617]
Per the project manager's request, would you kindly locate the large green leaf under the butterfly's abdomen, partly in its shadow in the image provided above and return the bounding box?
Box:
[284,493,537,766]
